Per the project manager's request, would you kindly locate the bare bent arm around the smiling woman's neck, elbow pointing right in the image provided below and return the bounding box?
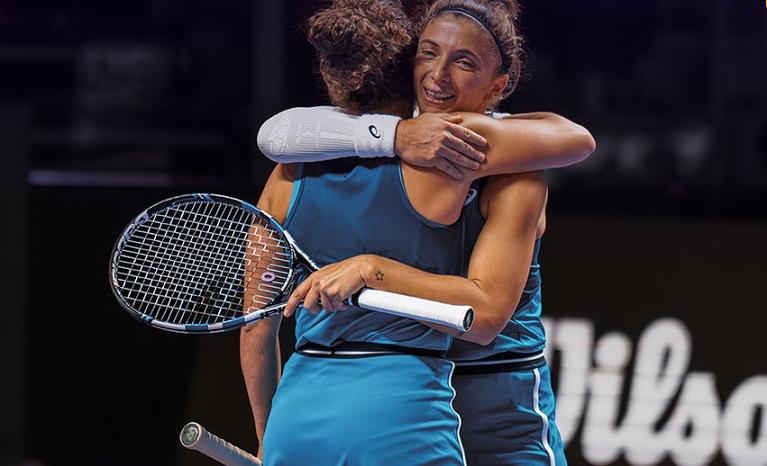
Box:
[460,112,596,176]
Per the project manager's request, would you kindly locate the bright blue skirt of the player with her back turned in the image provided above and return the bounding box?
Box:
[263,353,466,466]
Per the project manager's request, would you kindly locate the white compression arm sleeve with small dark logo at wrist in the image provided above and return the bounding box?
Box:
[257,107,400,163]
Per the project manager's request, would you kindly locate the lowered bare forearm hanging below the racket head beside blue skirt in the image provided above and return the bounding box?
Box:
[240,317,280,442]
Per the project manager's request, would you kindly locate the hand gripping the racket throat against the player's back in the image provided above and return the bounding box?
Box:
[283,255,375,317]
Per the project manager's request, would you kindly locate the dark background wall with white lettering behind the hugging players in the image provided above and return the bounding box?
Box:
[0,0,767,465]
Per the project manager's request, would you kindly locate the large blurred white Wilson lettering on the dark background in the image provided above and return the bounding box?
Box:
[544,318,767,466]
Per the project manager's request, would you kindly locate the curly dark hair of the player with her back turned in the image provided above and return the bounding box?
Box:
[308,0,416,113]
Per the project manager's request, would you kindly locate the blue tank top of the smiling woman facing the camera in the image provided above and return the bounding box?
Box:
[448,180,546,361]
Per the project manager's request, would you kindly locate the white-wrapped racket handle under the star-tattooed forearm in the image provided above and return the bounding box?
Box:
[349,288,474,332]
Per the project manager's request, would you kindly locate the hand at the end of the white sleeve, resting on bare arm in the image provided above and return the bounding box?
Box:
[394,113,487,180]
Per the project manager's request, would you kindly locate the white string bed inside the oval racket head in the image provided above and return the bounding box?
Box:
[117,202,291,323]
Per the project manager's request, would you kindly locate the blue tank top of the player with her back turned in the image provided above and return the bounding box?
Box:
[285,158,464,351]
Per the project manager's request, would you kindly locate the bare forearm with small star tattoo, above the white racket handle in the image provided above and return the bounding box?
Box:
[363,255,522,344]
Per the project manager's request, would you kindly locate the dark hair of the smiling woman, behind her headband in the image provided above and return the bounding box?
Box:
[418,0,523,100]
